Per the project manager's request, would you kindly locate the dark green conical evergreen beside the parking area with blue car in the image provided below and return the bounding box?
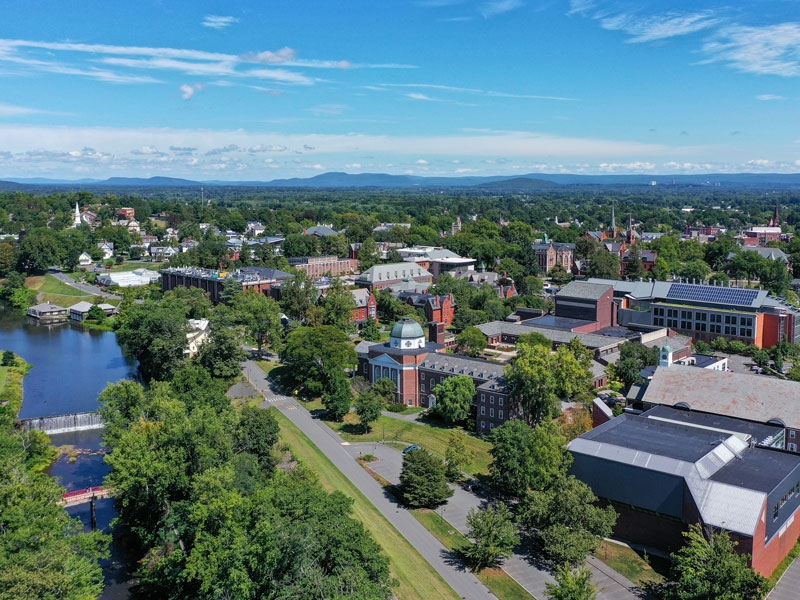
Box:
[398,448,453,508]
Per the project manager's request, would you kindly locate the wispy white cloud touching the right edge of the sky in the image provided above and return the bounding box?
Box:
[703,23,800,77]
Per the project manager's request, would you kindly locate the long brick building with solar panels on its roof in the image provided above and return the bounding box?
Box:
[589,279,800,348]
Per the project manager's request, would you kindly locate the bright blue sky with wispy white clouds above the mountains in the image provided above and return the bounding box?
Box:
[0,0,800,181]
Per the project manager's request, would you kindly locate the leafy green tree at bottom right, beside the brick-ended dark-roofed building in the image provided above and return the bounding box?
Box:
[664,525,769,600]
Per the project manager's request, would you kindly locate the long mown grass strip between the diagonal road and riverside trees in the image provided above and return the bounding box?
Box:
[272,409,459,600]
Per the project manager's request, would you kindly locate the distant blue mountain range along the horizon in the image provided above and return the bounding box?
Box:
[0,173,800,193]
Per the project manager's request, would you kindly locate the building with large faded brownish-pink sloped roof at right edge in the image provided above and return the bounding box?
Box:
[628,364,800,453]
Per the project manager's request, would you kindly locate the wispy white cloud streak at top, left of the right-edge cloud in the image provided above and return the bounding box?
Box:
[595,11,720,44]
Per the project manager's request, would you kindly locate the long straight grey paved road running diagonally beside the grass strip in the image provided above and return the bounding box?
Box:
[242,361,496,600]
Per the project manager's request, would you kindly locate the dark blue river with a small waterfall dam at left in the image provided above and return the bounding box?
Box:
[0,304,136,600]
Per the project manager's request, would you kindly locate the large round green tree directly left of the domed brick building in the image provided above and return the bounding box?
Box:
[280,325,356,398]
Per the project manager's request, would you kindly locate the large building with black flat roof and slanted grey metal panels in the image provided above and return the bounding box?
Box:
[569,408,800,577]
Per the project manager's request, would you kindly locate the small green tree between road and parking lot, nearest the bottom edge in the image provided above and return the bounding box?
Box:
[463,503,519,571]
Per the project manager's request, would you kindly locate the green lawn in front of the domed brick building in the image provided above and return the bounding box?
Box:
[328,413,492,475]
